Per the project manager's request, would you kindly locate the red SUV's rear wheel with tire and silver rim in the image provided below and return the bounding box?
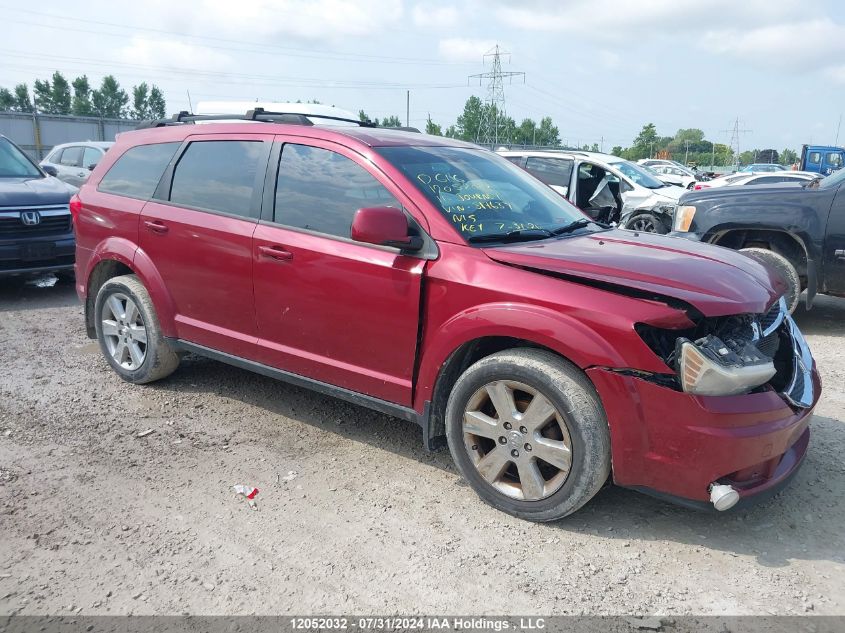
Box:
[94,275,179,384]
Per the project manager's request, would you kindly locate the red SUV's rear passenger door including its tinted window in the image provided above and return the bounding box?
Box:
[139,134,272,358]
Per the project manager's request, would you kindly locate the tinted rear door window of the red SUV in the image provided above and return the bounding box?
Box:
[170,140,266,217]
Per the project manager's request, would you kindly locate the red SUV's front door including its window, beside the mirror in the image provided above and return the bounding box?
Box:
[253,137,425,405]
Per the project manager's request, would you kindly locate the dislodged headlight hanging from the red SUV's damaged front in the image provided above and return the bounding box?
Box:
[675,334,775,396]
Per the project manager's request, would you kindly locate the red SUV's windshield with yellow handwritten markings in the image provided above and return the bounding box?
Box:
[377,147,589,243]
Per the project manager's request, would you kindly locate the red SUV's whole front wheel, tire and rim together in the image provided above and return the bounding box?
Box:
[446,349,610,521]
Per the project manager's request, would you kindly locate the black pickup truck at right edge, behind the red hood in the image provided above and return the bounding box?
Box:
[672,169,845,311]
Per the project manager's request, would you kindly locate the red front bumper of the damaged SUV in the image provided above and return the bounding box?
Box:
[587,364,821,505]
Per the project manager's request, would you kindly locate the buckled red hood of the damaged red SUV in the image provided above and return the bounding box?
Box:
[484,230,786,317]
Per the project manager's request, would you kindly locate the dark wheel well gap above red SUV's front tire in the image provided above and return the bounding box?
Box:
[423,336,559,448]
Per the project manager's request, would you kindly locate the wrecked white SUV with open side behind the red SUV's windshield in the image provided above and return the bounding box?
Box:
[498,150,686,233]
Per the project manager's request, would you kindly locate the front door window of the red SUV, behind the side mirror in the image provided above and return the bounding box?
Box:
[273,143,402,238]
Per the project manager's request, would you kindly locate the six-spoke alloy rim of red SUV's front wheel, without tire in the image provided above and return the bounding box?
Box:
[463,380,572,501]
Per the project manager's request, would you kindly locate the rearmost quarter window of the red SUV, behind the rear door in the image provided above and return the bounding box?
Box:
[97,142,181,200]
